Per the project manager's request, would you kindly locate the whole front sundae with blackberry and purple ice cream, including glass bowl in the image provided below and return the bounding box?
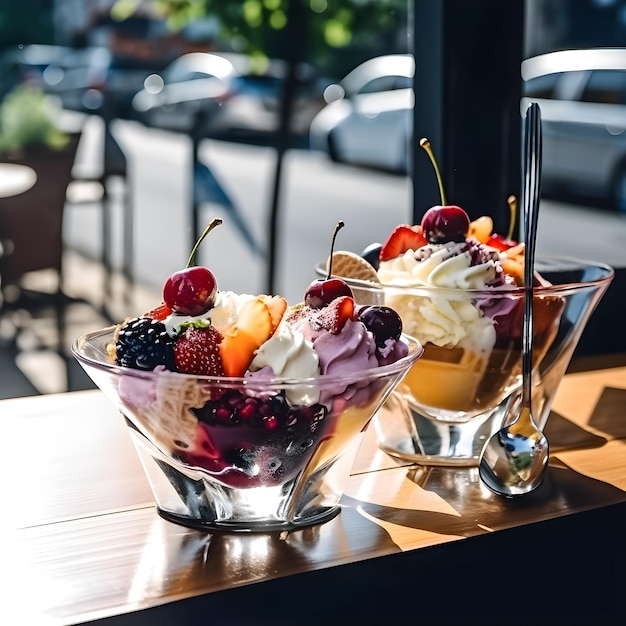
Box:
[75,220,422,525]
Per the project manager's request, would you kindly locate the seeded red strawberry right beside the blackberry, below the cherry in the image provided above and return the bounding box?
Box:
[174,322,224,376]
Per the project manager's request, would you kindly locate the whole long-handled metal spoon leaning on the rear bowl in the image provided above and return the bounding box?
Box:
[479,103,550,496]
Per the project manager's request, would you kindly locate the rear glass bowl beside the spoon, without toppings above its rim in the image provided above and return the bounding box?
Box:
[318,257,614,466]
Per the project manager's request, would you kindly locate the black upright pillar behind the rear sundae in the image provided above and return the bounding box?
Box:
[412,0,525,234]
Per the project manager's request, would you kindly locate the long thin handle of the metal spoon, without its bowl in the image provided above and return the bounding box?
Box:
[522,102,542,409]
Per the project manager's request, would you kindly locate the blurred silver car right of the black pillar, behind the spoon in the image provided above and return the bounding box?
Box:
[522,48,626,212]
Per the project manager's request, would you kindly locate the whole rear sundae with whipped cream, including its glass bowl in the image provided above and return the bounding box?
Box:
[317,138,614,466]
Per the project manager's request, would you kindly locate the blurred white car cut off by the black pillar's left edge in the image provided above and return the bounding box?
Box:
[309,54,415,172]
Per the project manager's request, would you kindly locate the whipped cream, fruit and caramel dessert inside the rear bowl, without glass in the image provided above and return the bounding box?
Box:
[334,140,564,421]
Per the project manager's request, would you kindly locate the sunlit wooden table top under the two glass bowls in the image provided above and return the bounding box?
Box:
[0,367,626,624]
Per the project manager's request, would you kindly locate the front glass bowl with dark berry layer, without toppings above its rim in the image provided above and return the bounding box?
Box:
[73,327,422,531]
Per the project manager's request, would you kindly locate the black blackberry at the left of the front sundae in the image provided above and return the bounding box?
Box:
[115,317,176,371]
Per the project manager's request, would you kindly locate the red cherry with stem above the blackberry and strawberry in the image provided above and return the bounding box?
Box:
[163,218,222,316]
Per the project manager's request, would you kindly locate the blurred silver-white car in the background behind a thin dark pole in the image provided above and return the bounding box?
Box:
[127,52,322,138]
